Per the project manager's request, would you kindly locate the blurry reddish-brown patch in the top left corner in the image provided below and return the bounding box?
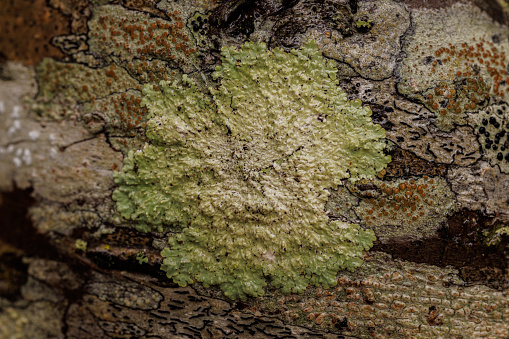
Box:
[0,0,71,65]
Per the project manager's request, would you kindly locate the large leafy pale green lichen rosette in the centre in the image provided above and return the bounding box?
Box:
[113,42,390,299]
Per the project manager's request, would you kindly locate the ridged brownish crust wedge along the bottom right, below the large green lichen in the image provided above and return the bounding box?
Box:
[252,252,509,338]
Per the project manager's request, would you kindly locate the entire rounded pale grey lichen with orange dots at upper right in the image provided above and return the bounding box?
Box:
[398,3,508,132]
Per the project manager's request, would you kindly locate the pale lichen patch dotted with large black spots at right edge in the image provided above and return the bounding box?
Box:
[468,104,509,173]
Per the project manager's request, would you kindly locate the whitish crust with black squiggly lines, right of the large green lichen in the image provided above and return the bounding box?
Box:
[340,78,481,168]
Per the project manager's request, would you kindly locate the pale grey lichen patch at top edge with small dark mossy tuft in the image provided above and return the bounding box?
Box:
[299,0,410,80]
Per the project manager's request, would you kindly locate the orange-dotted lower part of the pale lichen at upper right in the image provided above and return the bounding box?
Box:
[408,39,509,131]
